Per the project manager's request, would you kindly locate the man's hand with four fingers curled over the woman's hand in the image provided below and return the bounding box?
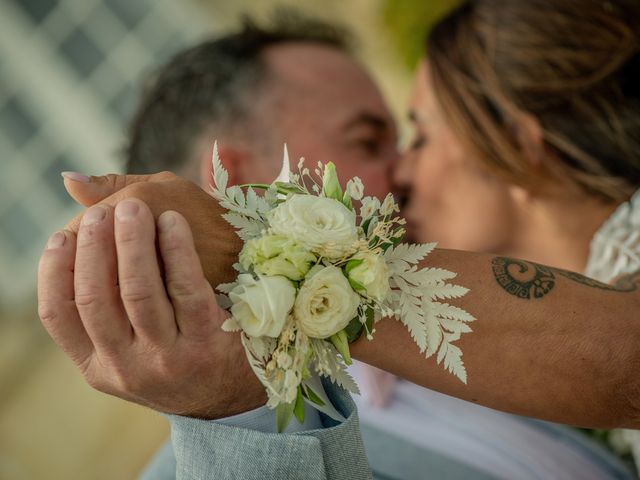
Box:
[38,197,266,418]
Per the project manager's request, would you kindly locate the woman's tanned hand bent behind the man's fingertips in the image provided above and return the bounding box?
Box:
[65,172,242,288]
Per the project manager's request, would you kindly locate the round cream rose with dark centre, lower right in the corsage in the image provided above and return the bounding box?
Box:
[293,265,360,338]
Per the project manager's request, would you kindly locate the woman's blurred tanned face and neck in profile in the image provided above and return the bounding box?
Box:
[395,62,516,253]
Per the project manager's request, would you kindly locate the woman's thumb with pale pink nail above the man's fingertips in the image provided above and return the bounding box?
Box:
[61,172,175,207]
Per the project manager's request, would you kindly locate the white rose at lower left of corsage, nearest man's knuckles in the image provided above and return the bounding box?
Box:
[229,273,296,337]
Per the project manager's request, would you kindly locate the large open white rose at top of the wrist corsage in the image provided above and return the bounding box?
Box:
[269,195,358,260]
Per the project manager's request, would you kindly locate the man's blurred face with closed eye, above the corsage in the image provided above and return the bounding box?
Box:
[256,43,398,202]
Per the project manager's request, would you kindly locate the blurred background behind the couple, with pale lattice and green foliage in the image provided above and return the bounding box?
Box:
[0,0,452,480]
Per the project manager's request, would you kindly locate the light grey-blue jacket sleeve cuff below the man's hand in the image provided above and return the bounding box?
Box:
[141,378,372,480]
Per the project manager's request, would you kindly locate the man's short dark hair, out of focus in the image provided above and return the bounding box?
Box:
[125,10,351,173]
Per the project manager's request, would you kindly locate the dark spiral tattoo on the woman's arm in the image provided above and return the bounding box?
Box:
[491,257,640,299]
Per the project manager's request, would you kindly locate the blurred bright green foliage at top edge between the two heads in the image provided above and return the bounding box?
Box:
[381,0,460,70]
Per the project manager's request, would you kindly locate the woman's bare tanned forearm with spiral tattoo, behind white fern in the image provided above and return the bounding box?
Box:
[352,250,640,427]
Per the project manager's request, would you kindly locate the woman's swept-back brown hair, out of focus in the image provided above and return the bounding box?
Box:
[427,0,640,202]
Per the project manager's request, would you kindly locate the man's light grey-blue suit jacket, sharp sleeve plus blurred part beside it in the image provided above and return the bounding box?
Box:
[141,382,504,480]
